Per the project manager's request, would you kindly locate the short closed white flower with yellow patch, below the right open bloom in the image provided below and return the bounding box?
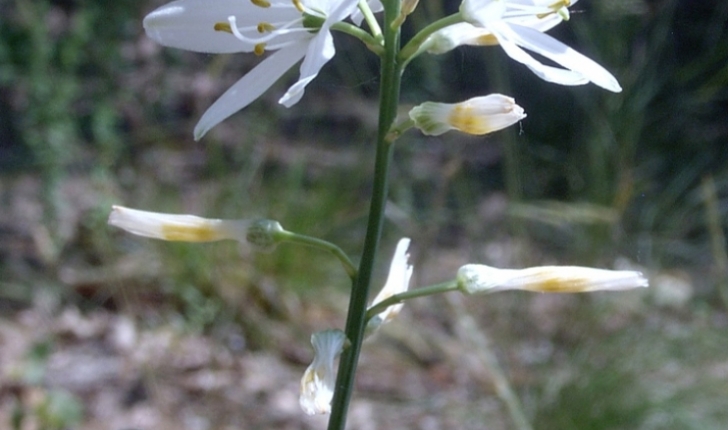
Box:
[409,94,526,136]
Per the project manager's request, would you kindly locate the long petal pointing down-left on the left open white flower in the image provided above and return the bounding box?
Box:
[195,41,308,140]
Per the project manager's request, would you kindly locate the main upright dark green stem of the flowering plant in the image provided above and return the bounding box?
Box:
[328,0,401,430]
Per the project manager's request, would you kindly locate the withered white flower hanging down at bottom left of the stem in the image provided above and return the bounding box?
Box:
[298,330,348,415]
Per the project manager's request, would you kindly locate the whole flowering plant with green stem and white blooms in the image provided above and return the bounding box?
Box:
[109,0,647,429]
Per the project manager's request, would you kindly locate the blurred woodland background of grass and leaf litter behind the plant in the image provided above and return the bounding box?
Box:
[0,0,728,429]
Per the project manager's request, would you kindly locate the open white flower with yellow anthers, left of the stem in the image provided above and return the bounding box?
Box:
[144,0,358,139]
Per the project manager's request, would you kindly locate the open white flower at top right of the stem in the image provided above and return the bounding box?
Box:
[426,0,622,92]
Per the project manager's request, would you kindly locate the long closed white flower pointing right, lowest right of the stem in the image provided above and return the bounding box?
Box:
[457,264,649,294]
